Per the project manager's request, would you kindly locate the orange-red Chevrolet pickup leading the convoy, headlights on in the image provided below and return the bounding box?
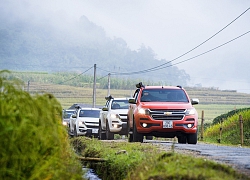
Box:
[127,83,199,144]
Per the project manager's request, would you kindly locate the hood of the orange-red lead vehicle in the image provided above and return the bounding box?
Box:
[141,102,193,109]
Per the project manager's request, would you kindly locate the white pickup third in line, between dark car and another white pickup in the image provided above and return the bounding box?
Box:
[69,107,101,138]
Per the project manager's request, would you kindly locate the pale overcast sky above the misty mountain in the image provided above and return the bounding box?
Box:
[2,0,250,93]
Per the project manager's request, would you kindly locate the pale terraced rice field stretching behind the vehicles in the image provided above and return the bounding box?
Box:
[24,82,250,123]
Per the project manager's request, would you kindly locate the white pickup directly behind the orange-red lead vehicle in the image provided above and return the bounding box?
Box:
[99,96,129,140]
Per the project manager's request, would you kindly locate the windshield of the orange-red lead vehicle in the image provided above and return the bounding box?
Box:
[141,89,188,102]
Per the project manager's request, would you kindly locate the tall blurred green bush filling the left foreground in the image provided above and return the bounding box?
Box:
[0,71,82,180]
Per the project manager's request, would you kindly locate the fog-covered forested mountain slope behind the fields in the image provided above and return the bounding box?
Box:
[0,1,189,86]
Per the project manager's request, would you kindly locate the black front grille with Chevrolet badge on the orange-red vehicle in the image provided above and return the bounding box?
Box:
[149,109,186,120]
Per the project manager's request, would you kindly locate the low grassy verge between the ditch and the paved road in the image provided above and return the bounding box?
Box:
[71,137,250,180]
